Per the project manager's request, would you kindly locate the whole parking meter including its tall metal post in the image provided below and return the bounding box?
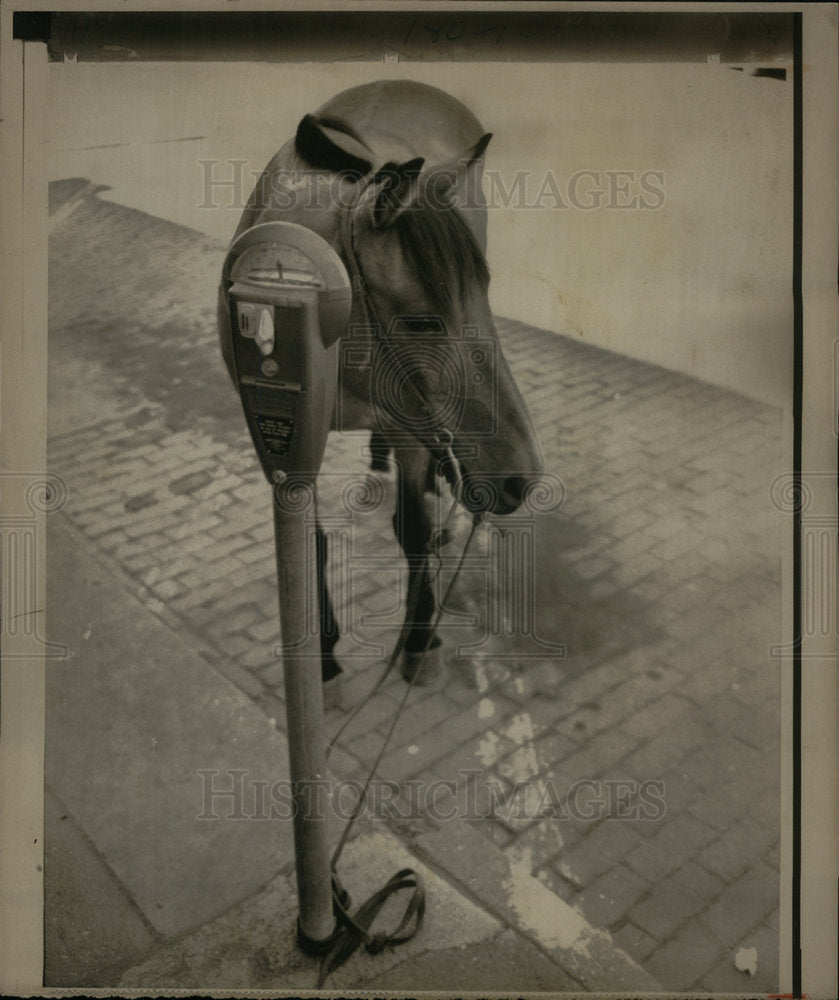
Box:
[221,222,352,950]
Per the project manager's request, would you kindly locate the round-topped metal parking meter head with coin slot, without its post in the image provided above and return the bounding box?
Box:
[222,222,352,481]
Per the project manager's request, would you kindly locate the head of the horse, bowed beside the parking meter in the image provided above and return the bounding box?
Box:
[298,119,542,514]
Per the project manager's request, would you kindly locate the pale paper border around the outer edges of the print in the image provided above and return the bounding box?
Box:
[0,0,839,997]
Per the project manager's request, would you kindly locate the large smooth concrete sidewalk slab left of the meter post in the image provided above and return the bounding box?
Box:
[45,519,293,952]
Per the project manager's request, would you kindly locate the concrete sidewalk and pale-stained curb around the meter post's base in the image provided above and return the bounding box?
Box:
[119,823,664,995]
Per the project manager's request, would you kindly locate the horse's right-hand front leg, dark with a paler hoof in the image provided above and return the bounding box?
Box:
[393,447,442,684]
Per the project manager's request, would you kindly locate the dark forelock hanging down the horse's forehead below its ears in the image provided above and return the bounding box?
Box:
[394,197,489,315]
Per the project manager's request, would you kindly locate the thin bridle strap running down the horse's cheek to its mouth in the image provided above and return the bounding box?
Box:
[340,183,463,500]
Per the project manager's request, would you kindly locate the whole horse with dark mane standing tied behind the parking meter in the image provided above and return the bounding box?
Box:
[219,80,543,683]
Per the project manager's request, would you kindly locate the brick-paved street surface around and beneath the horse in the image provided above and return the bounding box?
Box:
[49,181,782,992]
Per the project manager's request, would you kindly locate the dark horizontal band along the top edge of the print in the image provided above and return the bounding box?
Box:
[26,6,793,68]
